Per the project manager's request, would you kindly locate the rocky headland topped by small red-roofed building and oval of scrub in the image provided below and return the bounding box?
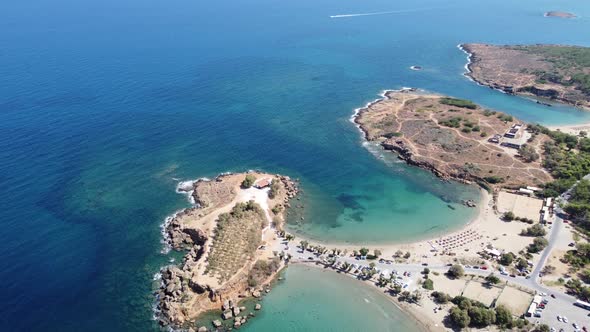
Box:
[157,173,298,330]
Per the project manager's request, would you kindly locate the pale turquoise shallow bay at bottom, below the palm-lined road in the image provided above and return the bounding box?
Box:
[244,265,420,332]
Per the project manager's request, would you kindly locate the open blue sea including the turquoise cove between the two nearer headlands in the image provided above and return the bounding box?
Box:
[0,0,590,331]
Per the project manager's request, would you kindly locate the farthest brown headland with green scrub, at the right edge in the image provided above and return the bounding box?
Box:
[460,44,590,109]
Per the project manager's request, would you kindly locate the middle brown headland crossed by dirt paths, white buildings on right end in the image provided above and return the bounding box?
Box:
[355,90,552,187]
